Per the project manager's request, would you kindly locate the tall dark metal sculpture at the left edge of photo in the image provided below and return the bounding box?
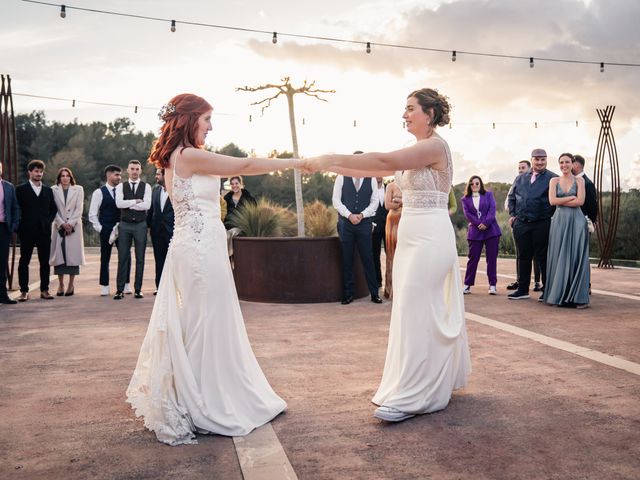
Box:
[0,75,18,289]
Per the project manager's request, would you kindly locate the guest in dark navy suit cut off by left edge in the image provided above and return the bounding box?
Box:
[0,163,20,305]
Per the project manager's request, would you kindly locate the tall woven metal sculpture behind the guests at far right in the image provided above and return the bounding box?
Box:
[593,105,620,268]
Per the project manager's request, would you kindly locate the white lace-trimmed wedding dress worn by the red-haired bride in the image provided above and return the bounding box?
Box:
[127,154,286,445]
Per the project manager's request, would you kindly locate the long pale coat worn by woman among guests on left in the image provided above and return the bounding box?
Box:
[49,185,85,266]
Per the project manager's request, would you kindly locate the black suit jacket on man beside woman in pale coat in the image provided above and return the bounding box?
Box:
[16,182,58,237]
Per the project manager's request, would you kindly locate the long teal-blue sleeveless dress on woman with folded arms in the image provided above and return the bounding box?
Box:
[542,179,591,306]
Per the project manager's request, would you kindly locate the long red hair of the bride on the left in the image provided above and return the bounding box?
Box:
[149,93,213,168]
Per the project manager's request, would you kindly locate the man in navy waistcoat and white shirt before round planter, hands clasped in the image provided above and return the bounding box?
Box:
[333,164,382,305]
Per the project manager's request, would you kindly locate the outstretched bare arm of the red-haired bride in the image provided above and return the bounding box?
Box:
[176,148,300,177]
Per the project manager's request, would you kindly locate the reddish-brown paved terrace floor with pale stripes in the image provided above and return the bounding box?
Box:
[0,252,640,480]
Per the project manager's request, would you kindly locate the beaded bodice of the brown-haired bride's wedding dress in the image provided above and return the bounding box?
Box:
[396,140,453,209]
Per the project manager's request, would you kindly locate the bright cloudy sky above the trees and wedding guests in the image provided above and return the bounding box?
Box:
[0,0,640,189]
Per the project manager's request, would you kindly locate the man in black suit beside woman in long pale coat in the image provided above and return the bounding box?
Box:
[16,160,58,302]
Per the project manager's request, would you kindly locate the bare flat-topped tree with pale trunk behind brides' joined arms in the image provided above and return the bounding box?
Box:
[236,77,335,237]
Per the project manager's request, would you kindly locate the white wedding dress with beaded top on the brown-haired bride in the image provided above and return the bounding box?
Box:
[373,140,471,414]
